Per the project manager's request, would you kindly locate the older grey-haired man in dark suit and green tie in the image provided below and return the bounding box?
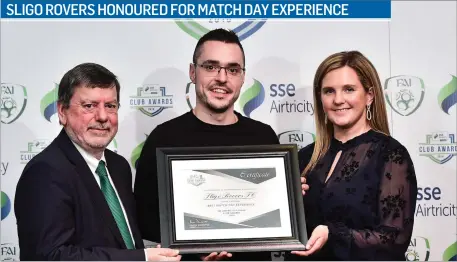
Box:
[14,63,181,261]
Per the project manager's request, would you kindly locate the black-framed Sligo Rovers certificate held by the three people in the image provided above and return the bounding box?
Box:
[157,144,308,254]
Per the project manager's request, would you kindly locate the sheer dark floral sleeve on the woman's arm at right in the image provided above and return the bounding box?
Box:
[326,145,417,260]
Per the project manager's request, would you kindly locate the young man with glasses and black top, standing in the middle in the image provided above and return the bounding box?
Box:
[134,29,279,261]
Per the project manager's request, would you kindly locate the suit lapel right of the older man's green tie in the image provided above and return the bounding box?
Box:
[105,151,143,248]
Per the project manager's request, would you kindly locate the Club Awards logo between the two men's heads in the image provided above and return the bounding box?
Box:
[130,84,173,117]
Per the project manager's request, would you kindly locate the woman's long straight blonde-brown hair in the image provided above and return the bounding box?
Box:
[302,51,390,175]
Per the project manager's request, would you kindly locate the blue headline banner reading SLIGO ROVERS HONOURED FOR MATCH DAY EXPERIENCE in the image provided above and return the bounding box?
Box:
[1,0,391,19]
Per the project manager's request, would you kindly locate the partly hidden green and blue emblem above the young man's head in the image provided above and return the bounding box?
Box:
[176,18,266,41]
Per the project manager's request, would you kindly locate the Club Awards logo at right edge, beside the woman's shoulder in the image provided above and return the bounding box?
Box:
[419,132,457,164]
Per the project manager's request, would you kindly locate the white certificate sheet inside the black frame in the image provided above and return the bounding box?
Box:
[171,157,292,241]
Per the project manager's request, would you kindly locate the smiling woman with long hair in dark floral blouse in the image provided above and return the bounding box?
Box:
[286,51,417,260]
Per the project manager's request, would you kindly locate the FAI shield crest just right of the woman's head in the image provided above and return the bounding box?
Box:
[384,75,425,116]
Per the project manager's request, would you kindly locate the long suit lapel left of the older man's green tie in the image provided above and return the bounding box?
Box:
[57,129,127,249]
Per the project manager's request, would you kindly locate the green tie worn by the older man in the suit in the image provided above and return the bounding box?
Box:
[95,160,135,249]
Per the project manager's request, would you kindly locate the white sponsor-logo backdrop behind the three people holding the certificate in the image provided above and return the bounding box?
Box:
[0,1,457,261]
